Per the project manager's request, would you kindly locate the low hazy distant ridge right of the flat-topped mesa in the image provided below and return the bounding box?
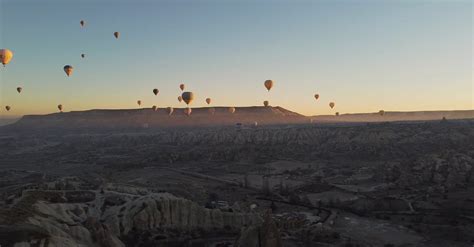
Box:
[311,110,474,122]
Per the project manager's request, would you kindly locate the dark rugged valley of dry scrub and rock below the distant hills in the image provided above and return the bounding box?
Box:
[0,109,474,246]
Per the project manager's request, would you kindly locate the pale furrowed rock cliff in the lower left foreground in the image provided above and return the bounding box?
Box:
[0,185,259,247]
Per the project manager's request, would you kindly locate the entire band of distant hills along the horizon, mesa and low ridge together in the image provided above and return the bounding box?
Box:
[1,106,474,130]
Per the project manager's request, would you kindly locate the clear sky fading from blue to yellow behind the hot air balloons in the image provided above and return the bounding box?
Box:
[0,0,474,117]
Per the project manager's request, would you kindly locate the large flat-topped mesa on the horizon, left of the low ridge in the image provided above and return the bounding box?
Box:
[7,106,309,129]
